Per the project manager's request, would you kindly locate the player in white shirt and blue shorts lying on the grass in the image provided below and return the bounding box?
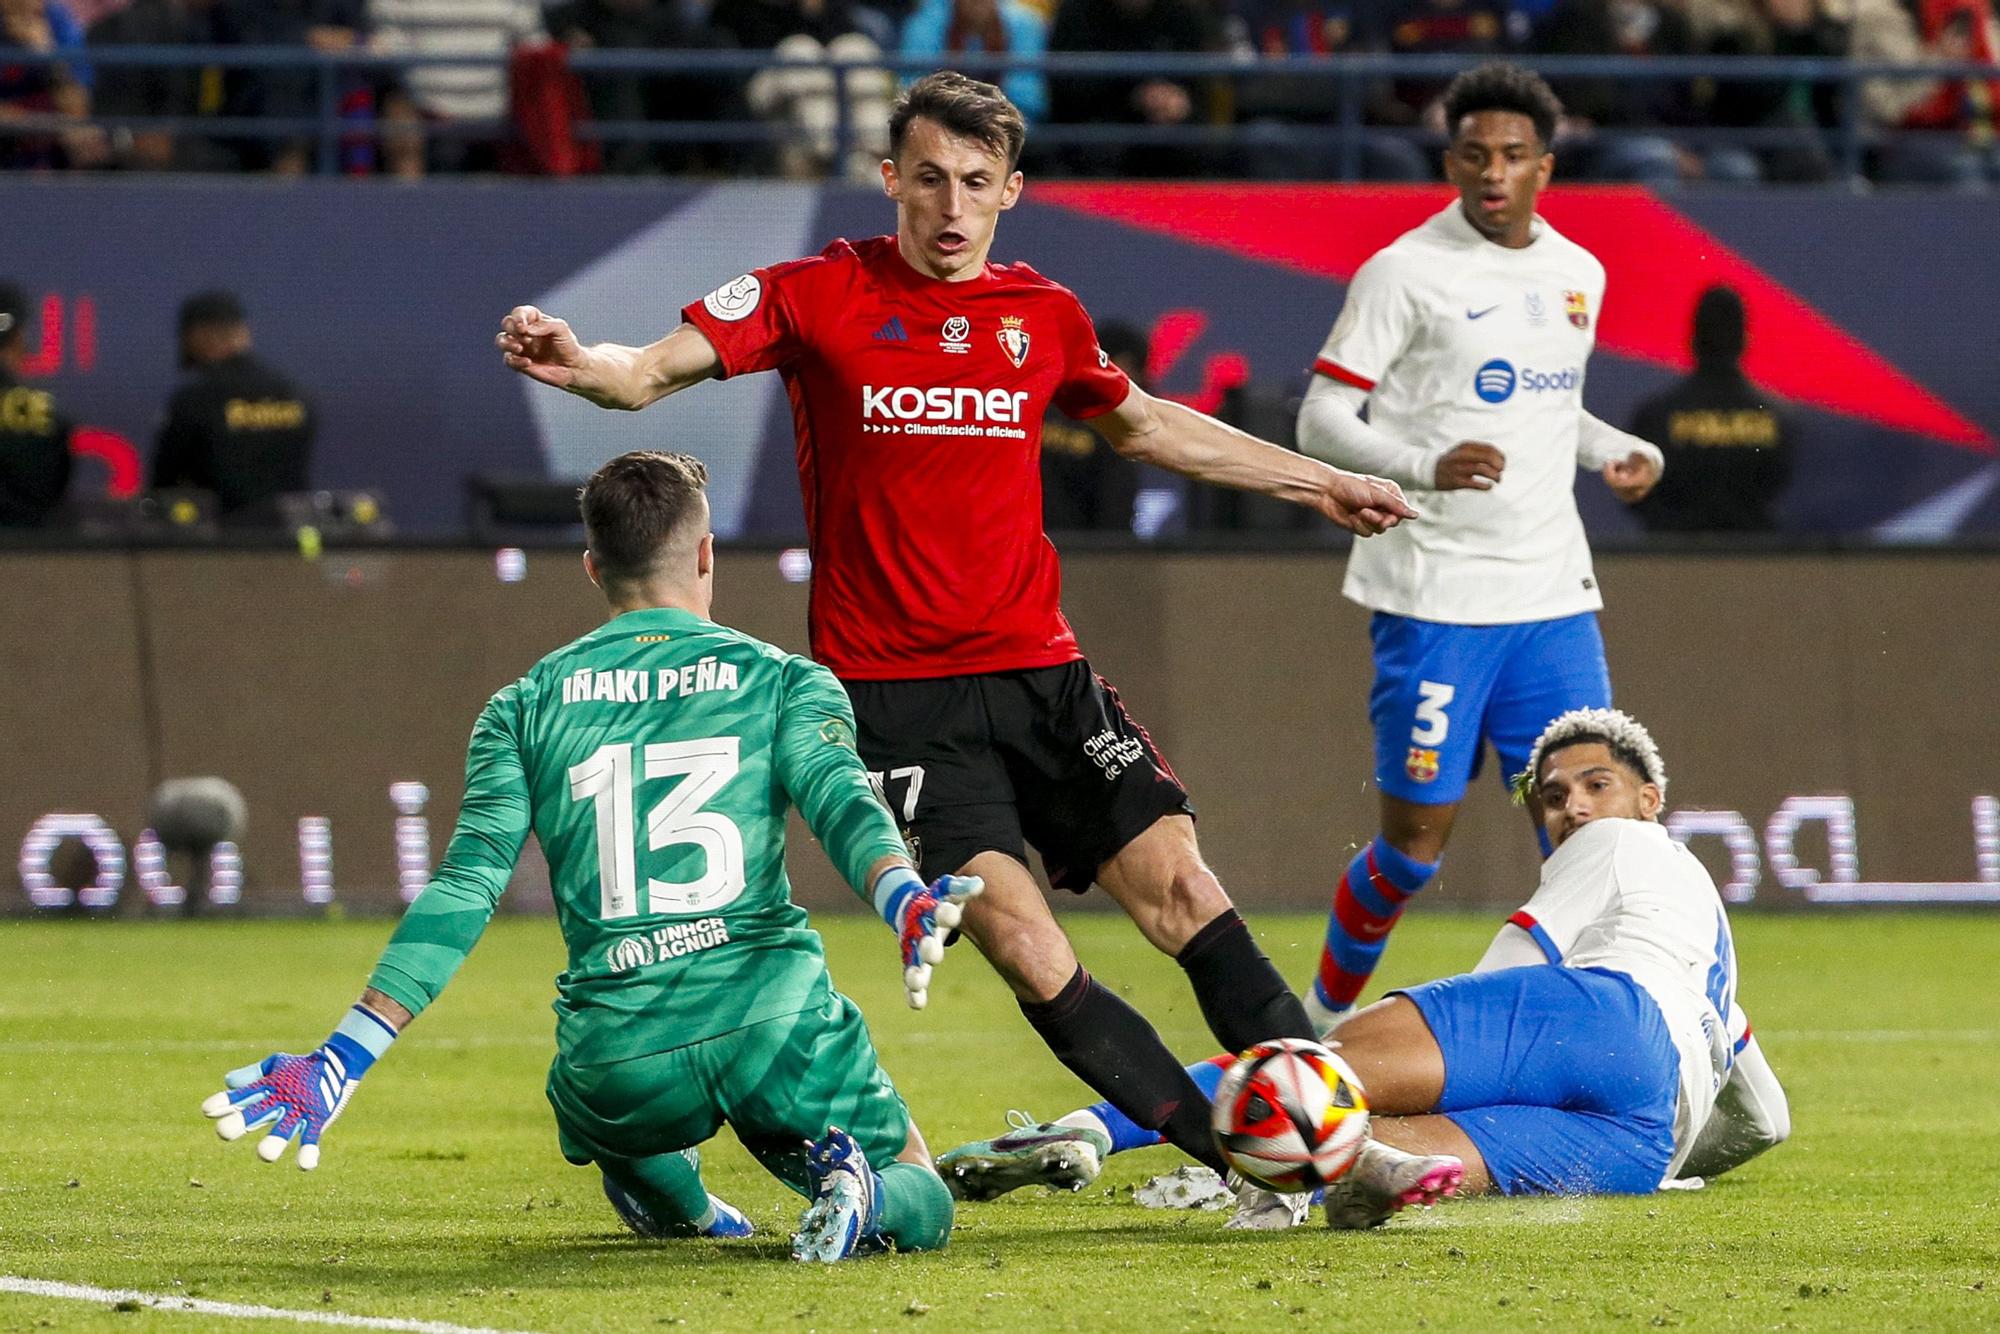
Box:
[938,710,1790,1228]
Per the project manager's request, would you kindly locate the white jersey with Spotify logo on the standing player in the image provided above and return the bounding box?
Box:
[1316,202,1604,626]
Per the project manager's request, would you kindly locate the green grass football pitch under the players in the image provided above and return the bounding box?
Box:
[0,912,2000,1334]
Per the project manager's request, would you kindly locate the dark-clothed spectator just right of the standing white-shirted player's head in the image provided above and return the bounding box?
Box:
[1534,0,1758,186]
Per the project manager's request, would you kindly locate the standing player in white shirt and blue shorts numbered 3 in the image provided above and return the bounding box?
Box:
[1298,64,1660,1032]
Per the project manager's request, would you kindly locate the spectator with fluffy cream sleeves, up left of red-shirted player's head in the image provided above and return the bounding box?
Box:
[714,0,894,180]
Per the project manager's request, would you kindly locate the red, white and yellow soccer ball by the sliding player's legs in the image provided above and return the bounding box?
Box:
[1214,1038,1368,1194]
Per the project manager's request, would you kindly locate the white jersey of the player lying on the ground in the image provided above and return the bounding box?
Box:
[1474,820,1742,1178]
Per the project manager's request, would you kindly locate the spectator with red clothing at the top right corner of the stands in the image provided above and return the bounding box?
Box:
[1852,0,2000,190]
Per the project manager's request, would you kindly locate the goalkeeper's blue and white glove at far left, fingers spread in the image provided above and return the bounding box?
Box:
[202,1006,396,1172]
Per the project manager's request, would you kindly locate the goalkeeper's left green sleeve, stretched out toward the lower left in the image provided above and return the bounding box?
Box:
[368,686,530,1014]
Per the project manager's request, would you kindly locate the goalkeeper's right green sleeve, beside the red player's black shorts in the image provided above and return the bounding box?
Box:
[778,658,906,906]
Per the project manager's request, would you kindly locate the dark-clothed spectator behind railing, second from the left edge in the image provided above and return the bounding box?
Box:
[90,0,240,172]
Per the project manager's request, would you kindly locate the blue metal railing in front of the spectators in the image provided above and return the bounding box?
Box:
[0,46,2000,180]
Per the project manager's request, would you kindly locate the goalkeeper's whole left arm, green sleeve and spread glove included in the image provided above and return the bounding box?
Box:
[202,688,528,1172]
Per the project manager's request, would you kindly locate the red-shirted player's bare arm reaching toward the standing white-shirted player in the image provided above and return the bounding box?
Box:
[1090,386,1416,538]
